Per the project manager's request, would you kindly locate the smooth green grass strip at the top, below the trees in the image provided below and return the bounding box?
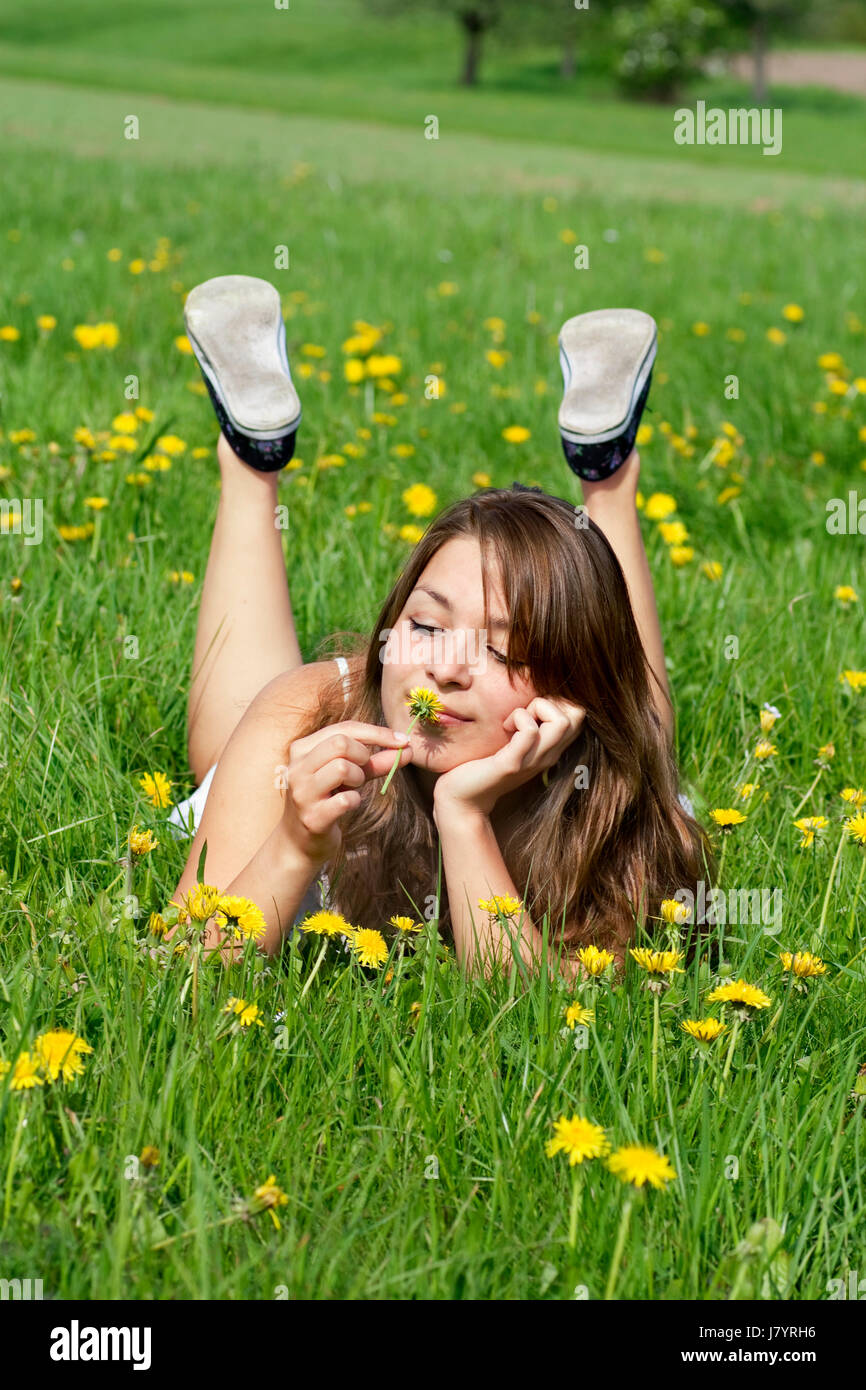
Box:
[0,0,866,181]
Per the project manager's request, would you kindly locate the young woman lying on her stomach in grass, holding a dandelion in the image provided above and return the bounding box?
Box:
[166,275,714,979]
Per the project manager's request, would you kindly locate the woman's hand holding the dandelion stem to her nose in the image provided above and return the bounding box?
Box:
[282,719,411,867]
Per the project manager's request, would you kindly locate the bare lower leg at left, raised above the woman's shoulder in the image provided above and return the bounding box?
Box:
[186,434,303,781]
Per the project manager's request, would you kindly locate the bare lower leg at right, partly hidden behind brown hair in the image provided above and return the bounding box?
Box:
[581,449,674,744]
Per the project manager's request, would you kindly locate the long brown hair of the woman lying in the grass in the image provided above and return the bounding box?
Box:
[284,488,716,959]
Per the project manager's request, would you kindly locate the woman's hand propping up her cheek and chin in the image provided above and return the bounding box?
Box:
[434,696,587,816]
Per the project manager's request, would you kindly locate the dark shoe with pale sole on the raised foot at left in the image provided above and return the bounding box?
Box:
[183,275,300,473]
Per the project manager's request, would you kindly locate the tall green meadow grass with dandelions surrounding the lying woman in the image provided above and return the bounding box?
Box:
[0,19,866,1300]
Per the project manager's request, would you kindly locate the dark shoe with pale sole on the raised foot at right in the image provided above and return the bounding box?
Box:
[559,309,656,482]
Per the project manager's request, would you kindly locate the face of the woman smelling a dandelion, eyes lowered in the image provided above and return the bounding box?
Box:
[381,537,538,799]
